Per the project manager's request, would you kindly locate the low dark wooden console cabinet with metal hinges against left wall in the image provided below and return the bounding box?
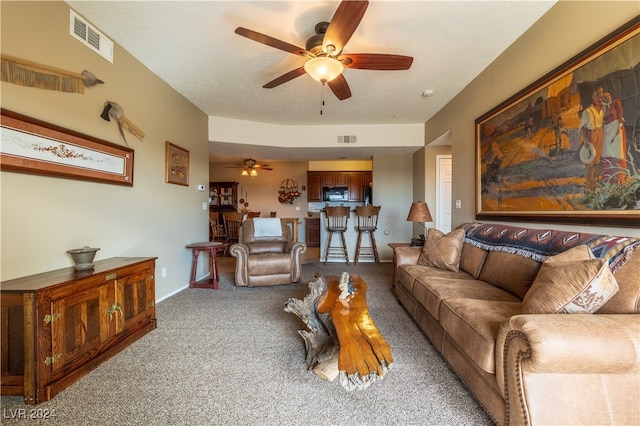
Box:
[0,257,156,404]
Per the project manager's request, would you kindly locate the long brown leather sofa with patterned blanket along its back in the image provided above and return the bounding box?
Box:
[394,223,640,425]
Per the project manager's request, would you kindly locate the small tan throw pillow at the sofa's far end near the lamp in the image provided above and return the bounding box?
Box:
[418,228,464,272]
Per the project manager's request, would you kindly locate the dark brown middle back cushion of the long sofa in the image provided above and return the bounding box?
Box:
[478,251,540,300]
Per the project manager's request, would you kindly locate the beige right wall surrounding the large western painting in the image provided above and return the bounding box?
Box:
[425,1,640,237]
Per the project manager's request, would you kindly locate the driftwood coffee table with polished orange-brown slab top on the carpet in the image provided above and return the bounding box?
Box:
[284,274,393,391]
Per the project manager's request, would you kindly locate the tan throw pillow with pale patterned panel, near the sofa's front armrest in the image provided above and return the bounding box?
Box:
[522,245,618,314]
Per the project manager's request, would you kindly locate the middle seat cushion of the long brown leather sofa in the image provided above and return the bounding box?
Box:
[413,272,520,319]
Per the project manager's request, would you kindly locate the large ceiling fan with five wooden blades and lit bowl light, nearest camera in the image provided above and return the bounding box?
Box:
[235,0,413,100]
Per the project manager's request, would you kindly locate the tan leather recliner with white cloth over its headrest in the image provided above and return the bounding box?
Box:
[230,218,307,287]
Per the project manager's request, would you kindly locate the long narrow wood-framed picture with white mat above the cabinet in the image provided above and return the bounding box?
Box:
[0,109,133,186]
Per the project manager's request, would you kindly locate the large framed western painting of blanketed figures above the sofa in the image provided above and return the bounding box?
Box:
[475,18,640,226]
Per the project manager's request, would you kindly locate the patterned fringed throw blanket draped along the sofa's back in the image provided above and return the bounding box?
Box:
[464,223,640,274]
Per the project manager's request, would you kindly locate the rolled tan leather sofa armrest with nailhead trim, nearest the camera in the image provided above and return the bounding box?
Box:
[496,314,640,424]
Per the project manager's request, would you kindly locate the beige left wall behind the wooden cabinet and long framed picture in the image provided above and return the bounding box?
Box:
[0,1,209,299]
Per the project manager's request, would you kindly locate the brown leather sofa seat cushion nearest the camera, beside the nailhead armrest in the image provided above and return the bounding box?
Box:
[440,298,522,374]
